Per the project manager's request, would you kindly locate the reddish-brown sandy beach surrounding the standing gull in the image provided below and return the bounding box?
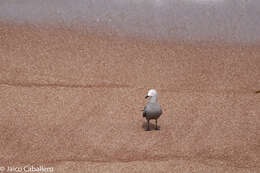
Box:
[0,23,260,173]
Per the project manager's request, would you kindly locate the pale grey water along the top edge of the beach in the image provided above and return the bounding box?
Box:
[0,0,260,43]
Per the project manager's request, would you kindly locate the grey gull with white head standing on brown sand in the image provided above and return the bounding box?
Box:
[143,89,162,131]
